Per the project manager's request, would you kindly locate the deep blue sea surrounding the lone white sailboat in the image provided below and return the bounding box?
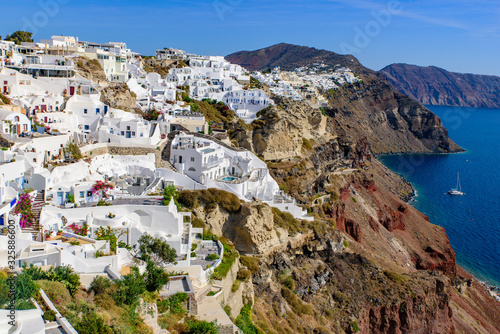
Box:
[380,106,500,287]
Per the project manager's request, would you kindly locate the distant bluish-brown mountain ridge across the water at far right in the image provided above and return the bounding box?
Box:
[380,64,500,108]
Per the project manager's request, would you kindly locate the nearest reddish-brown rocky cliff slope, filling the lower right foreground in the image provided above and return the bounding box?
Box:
[187,153,500,333]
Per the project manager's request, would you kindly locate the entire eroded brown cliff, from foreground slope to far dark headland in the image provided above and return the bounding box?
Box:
[184,45,500,333]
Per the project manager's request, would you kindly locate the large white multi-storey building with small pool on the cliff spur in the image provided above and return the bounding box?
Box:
[170,133,313,220]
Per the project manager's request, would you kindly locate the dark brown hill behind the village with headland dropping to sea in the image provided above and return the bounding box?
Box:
[226,44,461,153]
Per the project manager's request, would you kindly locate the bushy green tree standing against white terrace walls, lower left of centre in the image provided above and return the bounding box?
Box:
[138,233,177,265]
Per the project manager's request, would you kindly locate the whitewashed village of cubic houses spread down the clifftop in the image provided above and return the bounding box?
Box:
[0,36,358,334]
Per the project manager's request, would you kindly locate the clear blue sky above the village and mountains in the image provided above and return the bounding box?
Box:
[0,0,500,75]
